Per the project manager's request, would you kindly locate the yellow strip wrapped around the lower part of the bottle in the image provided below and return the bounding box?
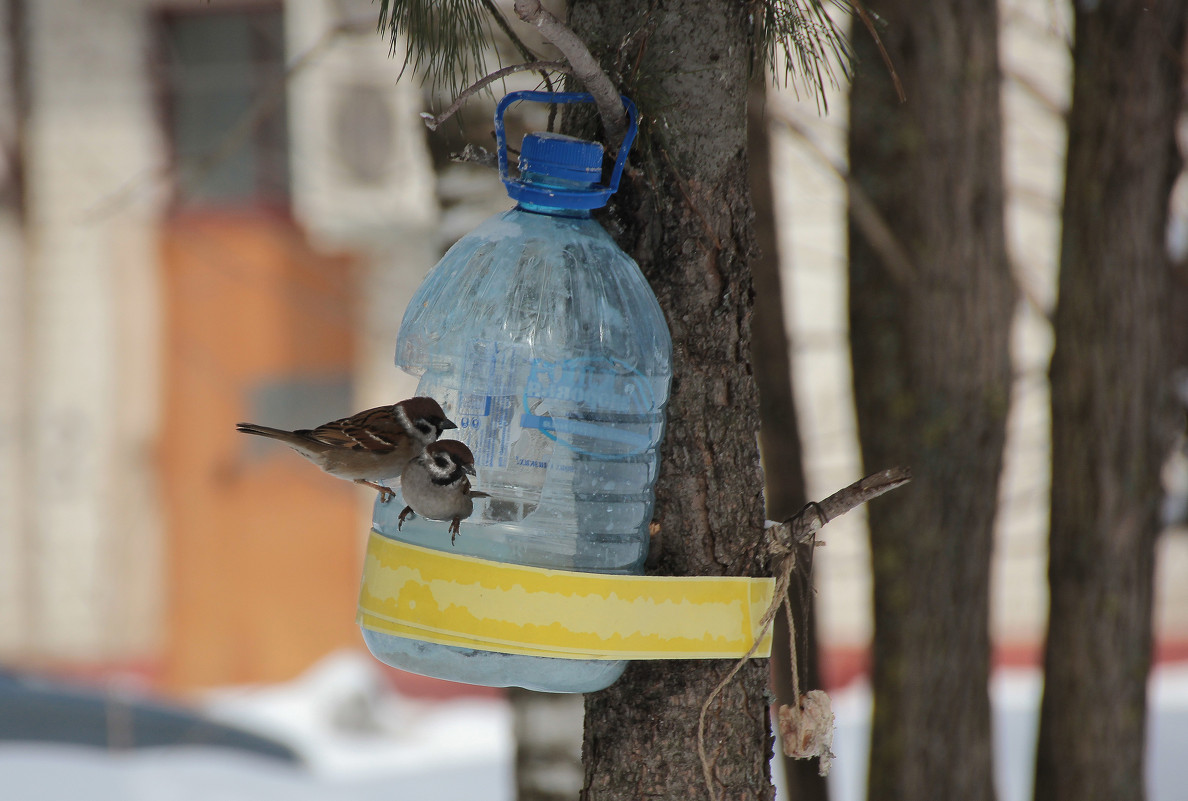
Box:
[358,531,775,660]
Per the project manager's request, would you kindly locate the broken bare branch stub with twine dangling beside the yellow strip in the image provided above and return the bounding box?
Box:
[697,467,911,801]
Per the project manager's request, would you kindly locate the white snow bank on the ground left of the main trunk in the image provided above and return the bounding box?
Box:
[0,651,514,801]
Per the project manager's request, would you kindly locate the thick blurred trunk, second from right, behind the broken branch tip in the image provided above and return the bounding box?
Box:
[849,0,1015,801]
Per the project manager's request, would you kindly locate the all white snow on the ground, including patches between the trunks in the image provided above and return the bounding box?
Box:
[0,652,1188,801]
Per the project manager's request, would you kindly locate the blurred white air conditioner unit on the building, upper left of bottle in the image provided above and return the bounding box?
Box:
[285,0,437,244]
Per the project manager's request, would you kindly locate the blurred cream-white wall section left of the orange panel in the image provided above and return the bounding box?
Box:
[0,0,167,658]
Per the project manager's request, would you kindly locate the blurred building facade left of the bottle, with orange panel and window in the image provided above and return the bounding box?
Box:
[0,0,437,688]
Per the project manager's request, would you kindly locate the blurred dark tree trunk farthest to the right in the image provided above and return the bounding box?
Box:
[1036,0,1188,801]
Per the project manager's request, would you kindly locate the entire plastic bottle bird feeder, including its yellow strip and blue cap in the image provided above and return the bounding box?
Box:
[359,92,771,692]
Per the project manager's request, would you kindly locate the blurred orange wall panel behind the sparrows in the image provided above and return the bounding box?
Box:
[160,216,366,689]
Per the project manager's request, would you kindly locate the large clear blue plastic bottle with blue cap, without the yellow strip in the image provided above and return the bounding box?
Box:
[364,93,672,693]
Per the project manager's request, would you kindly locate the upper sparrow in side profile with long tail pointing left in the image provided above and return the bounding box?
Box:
[235,398,457,503]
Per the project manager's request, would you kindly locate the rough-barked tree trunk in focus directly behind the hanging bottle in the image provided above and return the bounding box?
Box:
[570,0,773,801]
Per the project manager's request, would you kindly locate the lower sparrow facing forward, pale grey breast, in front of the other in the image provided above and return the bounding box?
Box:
[396,440,487,544]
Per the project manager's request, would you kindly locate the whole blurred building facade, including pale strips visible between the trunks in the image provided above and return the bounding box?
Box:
[0,0,1188,689]
